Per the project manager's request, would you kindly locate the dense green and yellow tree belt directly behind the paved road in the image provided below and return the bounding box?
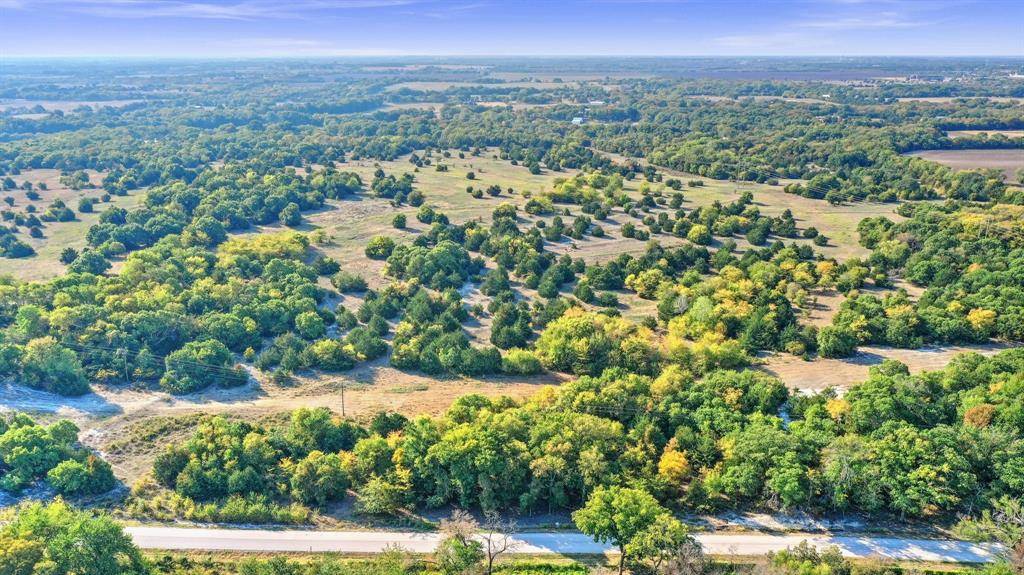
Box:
[144,343,1024,517]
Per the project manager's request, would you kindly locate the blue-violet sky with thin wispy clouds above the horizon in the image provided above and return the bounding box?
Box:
[0,0,1024,57]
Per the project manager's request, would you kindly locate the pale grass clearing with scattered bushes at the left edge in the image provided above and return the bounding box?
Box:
[0,170,144,280]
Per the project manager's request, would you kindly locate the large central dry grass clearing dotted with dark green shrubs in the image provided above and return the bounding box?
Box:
[249,150,900,327]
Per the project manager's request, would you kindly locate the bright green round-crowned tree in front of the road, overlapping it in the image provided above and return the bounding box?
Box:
[572,486,669,575]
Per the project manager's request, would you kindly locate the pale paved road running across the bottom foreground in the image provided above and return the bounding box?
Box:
[126,527,999,563]
